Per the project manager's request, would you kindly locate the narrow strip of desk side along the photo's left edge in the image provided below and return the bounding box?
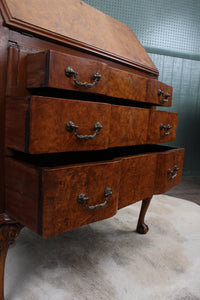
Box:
[0,14,8,213]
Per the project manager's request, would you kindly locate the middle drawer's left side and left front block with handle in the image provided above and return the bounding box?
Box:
[6,96,111,154]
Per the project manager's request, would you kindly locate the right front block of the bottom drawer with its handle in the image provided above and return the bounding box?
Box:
[154,149,184,194]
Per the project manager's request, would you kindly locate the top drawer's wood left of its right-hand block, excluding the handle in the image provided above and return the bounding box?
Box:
[27,50,155,102]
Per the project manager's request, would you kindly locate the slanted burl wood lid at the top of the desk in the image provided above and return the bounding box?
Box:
[0,0,158,75]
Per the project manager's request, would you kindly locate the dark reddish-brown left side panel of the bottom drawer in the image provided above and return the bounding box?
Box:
[5,158,40,232]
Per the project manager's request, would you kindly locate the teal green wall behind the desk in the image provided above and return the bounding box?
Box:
[84,0,200,176]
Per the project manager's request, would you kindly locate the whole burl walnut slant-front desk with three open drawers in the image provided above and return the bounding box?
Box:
[0,0,184,300]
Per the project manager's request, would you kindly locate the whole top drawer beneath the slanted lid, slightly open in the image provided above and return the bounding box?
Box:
[26,50,172,106]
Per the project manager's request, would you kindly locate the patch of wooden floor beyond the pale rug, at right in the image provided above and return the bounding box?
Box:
[165,177,200,205]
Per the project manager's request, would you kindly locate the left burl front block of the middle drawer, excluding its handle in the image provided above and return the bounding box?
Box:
[29,97,111,153]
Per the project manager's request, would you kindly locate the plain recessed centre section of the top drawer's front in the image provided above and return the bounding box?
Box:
[108,68,147,102]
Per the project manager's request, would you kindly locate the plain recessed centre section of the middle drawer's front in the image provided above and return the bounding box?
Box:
[109,105,149,147]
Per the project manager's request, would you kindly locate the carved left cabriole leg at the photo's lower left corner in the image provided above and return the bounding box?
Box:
[0,214,23,300]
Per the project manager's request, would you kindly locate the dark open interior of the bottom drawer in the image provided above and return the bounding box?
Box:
[9,145,176,167]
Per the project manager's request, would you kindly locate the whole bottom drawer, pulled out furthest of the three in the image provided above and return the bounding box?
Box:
[5,146,184,237]
